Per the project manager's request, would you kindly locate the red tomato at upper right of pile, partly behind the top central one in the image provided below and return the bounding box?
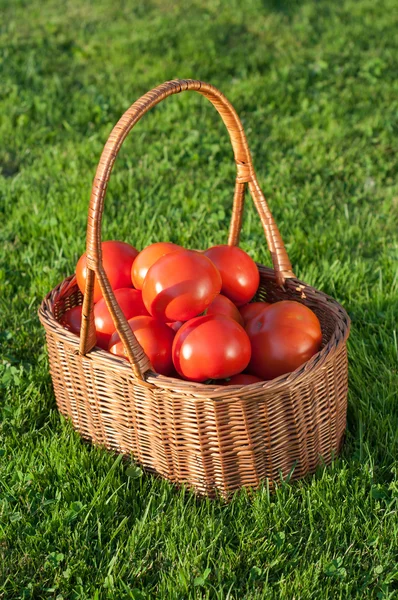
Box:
[204,245,260,306]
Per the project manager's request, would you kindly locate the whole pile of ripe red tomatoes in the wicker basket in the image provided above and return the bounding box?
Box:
[62,241,322,385]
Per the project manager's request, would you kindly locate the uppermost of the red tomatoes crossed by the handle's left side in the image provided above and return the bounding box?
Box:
[76,241,138,302]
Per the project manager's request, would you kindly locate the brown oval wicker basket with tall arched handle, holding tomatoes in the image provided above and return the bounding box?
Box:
[39,80,349,496]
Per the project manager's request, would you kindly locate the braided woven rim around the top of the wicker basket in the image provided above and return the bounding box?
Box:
[38,263,350,400]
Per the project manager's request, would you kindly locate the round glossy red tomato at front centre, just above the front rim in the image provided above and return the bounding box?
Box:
[173,315,250,381]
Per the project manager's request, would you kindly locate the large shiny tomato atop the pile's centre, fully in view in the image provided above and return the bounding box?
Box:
[142,250,221,322]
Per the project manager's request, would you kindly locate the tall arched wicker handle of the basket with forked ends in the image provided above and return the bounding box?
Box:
[79,79,294,380]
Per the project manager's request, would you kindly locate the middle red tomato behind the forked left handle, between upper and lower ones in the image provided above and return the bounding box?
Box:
[94,288,149,350]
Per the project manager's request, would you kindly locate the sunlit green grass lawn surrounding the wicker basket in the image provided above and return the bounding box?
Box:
[0,0,398,600]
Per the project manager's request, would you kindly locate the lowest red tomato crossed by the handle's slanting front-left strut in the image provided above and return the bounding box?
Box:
[109,316,174,375]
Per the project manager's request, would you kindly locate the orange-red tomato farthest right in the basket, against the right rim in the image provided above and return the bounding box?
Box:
[246,300,322,379]
